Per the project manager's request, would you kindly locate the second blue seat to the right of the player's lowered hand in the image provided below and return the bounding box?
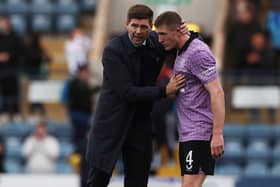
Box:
[246,140,272,161]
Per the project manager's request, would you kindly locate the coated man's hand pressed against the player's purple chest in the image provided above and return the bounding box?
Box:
[166,74,186,98]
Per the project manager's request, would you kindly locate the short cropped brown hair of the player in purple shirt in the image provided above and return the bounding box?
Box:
[155,11,182,30]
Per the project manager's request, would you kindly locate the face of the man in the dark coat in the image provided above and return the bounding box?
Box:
[126,19,151,45]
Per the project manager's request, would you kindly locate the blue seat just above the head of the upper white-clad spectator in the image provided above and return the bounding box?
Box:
[56,14,77,32]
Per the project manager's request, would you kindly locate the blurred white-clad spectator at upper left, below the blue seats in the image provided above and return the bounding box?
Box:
[64,28,93,75]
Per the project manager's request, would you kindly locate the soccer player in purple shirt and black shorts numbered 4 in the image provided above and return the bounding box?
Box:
[155,12,225,187]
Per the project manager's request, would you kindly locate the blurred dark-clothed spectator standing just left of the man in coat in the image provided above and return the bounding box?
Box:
[68,63,99,148]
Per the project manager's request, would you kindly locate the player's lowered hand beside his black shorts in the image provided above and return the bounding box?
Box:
[211,133,224,159]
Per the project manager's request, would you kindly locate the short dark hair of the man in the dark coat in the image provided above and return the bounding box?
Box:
[127,4,154,25]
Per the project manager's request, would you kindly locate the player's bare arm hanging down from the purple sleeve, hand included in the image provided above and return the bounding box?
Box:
[204,78,225,158]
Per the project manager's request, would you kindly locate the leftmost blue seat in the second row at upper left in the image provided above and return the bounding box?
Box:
[10,14,27,36]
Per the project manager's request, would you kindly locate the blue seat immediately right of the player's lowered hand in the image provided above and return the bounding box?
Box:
[221,139,245,164]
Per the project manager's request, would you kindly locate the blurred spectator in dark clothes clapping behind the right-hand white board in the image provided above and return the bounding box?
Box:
[243,31,277,123]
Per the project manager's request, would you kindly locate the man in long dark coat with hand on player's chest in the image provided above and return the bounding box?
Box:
[87,5,185,187]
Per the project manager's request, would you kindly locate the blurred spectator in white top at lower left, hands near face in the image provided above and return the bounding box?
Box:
[22,122,59,173]
